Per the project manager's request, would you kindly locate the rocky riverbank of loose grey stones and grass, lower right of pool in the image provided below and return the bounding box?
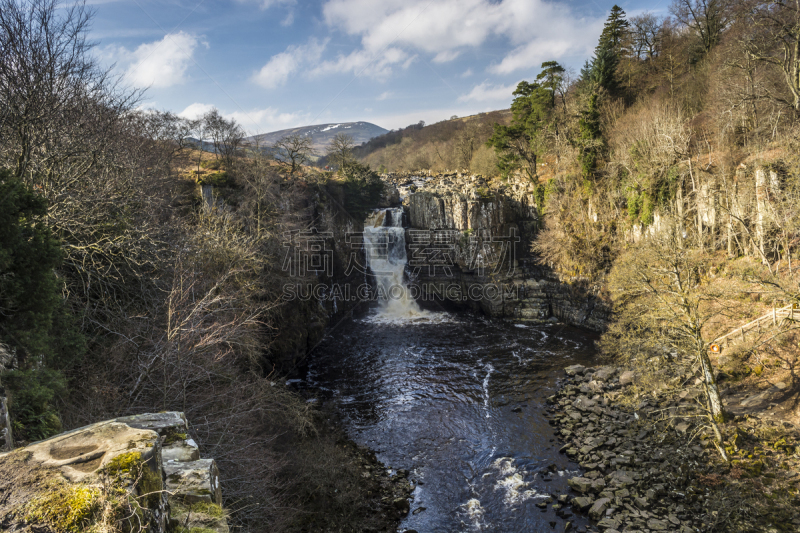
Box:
[548,365,800,533]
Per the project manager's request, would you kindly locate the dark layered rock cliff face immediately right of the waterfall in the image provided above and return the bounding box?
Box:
[384,174,609,331]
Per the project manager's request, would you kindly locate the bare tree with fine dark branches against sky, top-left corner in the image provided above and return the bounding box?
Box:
[0,0,138,179]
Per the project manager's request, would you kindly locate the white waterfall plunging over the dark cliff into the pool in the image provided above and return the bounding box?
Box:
[364,208,429,318]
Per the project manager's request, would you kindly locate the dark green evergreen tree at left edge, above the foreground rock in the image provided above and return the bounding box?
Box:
[0,171,85,440]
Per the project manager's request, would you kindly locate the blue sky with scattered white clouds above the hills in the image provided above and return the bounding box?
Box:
[87,0,668,134]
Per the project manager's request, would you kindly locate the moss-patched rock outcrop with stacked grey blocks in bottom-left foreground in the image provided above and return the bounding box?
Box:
[0,412,229,533]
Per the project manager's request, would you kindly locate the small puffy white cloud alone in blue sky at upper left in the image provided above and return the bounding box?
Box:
[115,31,203,87]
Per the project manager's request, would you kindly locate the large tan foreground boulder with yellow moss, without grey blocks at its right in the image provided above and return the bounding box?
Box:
[0,420,167,533]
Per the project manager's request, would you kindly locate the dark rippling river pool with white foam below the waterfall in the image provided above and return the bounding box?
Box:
[297,311,594,533]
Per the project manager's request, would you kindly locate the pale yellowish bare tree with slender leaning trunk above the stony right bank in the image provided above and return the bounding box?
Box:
[602,217,734,457]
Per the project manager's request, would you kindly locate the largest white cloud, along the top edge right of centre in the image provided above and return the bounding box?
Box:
[323,0,602,75]
